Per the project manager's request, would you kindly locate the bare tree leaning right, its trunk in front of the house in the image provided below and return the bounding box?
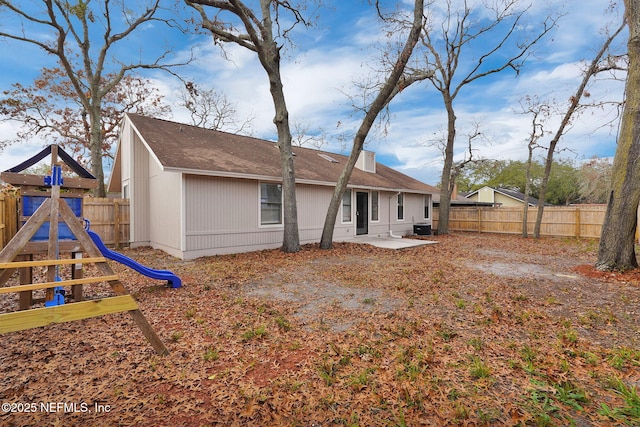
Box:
[320,0,424,249]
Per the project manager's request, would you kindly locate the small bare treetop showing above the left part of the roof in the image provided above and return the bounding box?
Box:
[178,82,253,134]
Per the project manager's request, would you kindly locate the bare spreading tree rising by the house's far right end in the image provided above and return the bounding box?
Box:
[411,0,557,234]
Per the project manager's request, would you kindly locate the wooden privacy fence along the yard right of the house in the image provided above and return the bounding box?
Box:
[433,205,607,239]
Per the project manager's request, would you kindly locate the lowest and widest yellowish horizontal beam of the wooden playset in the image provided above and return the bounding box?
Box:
[0,295,139,334]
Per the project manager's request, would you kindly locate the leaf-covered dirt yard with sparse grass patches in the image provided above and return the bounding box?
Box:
[0,234,640,427]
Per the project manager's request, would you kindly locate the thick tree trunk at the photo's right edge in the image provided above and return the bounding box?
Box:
[596,0,640,270]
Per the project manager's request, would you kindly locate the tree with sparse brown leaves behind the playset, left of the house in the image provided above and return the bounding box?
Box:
[0,68,171,166]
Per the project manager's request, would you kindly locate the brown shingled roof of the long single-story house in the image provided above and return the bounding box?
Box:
[110,114,438,194]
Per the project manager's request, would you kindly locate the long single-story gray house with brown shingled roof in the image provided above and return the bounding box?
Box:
[109,114,438,259]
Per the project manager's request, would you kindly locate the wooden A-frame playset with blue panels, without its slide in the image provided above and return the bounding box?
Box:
[0,145,168,355]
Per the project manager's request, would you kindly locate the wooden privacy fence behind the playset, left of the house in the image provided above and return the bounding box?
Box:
[0,194,129,249]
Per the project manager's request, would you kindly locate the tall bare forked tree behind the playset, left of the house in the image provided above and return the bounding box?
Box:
[0,0,189,196]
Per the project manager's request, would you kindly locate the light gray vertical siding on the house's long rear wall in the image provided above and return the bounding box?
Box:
[179,179,436,259]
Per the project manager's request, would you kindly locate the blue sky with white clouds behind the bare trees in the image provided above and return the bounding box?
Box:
[0,0,626,184]
